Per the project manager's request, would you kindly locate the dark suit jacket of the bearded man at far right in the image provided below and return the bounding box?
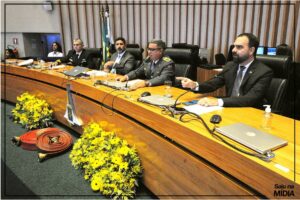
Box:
[198,60,273,107]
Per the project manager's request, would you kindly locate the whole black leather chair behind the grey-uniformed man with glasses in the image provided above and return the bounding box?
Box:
[165,48,196,87]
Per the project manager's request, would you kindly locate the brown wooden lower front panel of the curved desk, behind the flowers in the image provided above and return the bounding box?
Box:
[2,72,253,198]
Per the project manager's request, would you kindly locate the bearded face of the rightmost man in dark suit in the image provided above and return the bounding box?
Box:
[232,36,255,64]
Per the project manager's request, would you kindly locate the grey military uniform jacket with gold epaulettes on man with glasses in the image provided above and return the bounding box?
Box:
[127,57,175,86]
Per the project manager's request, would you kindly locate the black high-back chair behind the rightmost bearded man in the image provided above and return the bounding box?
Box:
[256,55,291,114]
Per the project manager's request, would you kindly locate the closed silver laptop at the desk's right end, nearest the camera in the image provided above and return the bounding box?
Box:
[216,123,288,154]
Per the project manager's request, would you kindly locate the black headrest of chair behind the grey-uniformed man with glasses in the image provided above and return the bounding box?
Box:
[165,48,195,64]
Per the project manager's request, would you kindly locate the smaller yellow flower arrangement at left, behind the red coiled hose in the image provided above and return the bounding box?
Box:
[12,92,53,130]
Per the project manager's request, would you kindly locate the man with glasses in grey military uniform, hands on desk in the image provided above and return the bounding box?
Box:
[118,40,175,89]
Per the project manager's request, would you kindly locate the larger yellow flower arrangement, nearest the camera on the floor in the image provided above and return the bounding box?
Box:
[70,122,142,199]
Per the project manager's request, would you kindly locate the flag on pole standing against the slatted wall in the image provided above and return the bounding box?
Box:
[100,5,114,67]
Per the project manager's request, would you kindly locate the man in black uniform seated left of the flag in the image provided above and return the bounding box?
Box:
[56,39,96,69]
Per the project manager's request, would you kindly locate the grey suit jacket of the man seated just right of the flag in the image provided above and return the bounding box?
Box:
[110,51,135,75]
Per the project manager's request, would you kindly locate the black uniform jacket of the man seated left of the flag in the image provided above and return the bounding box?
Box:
[60,49,96,69]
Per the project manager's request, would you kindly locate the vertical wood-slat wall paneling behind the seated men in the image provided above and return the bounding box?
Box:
[55,0,300,62]
